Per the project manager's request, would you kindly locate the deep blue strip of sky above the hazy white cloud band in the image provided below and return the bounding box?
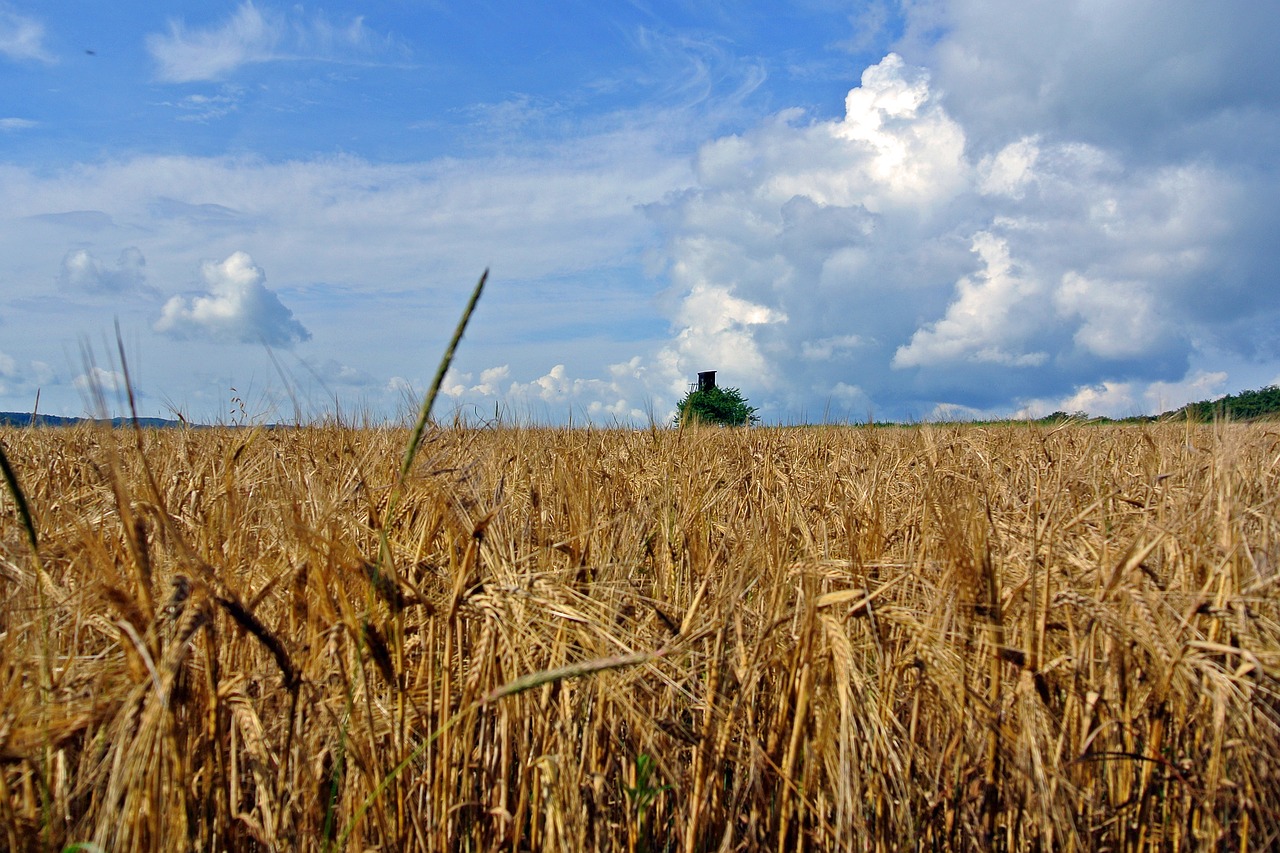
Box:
[3,0,896,167]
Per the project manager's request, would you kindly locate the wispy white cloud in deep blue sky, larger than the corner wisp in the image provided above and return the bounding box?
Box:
[146,0,407,82]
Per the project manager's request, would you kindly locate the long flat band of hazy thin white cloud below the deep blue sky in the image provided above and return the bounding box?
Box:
[0,137,689,289]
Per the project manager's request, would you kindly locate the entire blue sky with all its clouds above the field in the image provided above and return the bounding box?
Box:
[0,0,1280,425]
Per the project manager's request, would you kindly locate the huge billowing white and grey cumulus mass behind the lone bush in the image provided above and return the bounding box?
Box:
[654,43,1280,418]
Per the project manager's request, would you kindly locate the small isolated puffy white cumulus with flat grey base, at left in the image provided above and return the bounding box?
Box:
[155,252,311,347]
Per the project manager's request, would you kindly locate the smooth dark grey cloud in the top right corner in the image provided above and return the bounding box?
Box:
[902,0,1280,161]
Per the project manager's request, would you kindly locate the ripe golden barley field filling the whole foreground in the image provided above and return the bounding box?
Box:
[0,424,1280,852]
